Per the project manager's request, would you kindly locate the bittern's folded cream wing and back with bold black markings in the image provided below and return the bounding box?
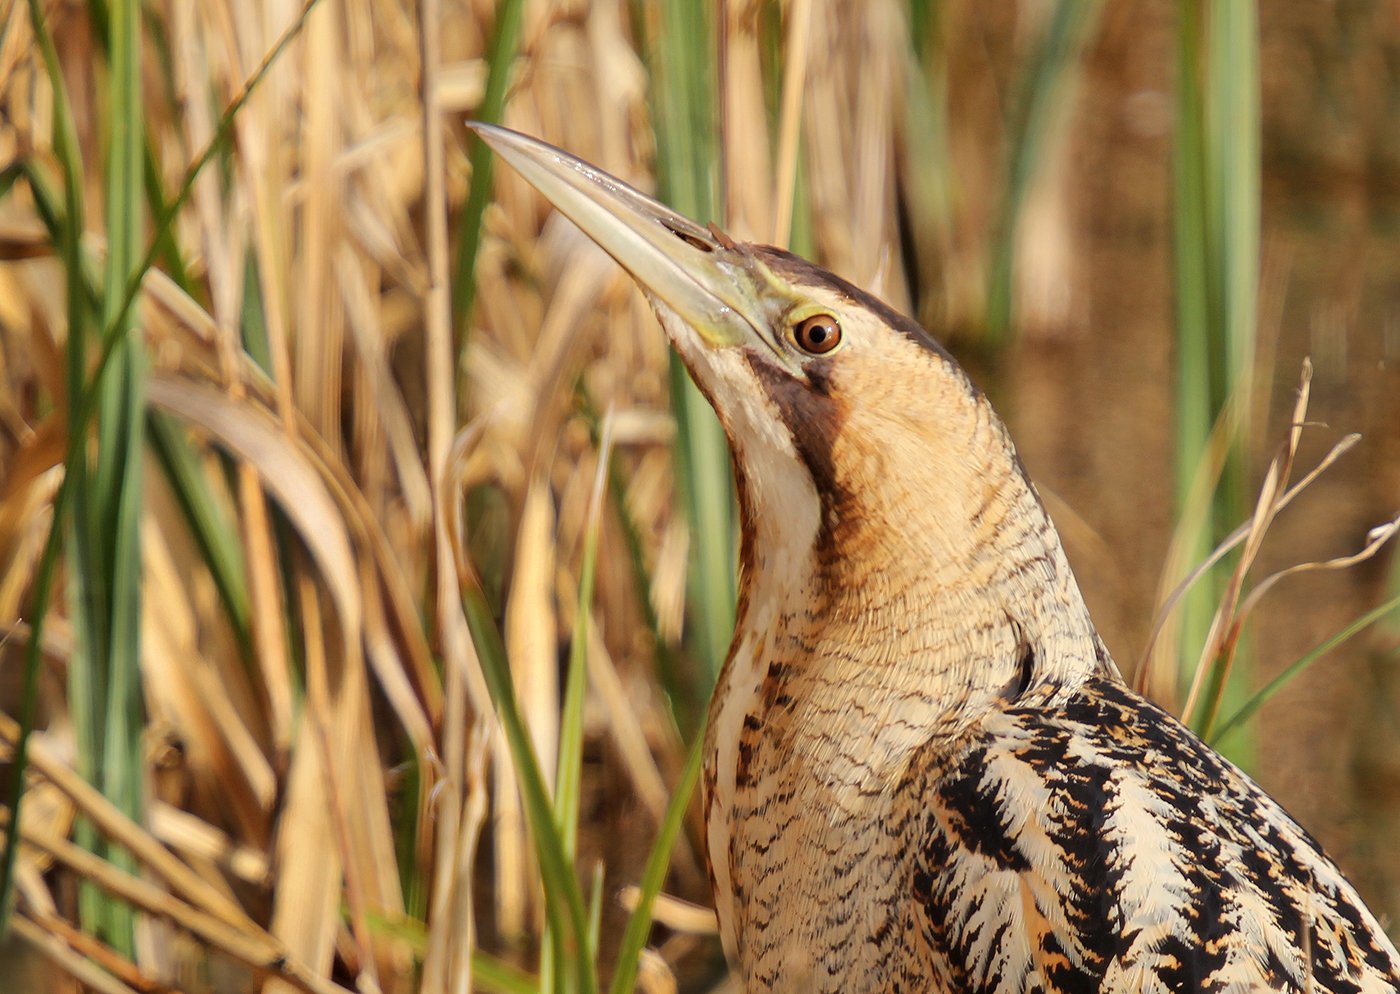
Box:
[907,676,1400,994]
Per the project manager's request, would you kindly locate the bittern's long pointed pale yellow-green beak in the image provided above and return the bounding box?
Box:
[468,122,767,347]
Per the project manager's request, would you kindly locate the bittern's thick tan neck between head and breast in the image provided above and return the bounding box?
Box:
[721,411,1112,738]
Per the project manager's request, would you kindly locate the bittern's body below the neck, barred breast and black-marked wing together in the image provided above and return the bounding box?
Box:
[728,673,1400,994]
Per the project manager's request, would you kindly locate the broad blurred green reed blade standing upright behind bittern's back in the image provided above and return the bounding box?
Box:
[1173,0,1260,766]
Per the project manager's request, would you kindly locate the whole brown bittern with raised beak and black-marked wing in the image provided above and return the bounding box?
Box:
[476,125,1400,994]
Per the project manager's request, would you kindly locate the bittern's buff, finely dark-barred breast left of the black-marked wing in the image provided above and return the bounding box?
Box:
[706,582,1047,991]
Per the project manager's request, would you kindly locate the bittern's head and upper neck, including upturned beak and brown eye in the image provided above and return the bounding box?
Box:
[472,125,1096,700]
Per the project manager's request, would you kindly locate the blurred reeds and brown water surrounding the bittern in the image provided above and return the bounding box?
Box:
[0,0,1400,994]
